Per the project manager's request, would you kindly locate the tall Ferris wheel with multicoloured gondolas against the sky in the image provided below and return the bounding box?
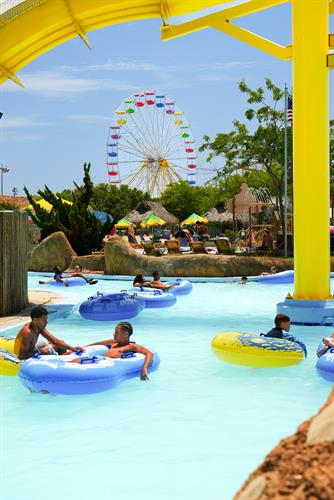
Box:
[107,91,197,196]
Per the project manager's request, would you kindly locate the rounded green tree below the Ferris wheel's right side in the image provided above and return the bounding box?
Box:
[160,181,220,221]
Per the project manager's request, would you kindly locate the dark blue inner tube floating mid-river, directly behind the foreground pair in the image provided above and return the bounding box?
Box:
[79,292,145,321]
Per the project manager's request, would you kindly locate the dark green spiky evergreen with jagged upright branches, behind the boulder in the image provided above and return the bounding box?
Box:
[24,163,111,255]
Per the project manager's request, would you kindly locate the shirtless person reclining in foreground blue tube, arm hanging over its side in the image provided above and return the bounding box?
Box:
[82,321,153,380]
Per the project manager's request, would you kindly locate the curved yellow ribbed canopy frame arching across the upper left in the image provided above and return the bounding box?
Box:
[0,0,227,85]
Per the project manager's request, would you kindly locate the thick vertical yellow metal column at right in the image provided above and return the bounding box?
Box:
[292,0,330,300]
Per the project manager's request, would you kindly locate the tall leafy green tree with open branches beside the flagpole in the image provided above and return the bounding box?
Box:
[200,78,292,238]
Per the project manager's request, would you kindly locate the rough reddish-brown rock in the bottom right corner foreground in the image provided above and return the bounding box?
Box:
[234,389,334,500]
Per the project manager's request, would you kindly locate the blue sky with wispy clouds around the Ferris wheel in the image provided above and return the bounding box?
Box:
[0,4,334,195]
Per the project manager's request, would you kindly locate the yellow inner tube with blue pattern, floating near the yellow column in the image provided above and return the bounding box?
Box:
[211,332,305,368]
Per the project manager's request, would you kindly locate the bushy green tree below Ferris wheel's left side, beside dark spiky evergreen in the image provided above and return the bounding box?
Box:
[91,184,151,221]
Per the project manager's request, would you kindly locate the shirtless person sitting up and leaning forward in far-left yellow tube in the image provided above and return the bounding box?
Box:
[14,306,83,359]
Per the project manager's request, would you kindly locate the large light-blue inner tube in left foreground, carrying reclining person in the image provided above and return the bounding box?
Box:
[19,346,160,395]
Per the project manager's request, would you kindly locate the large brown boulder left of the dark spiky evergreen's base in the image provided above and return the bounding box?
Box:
[29,231,76,272]
